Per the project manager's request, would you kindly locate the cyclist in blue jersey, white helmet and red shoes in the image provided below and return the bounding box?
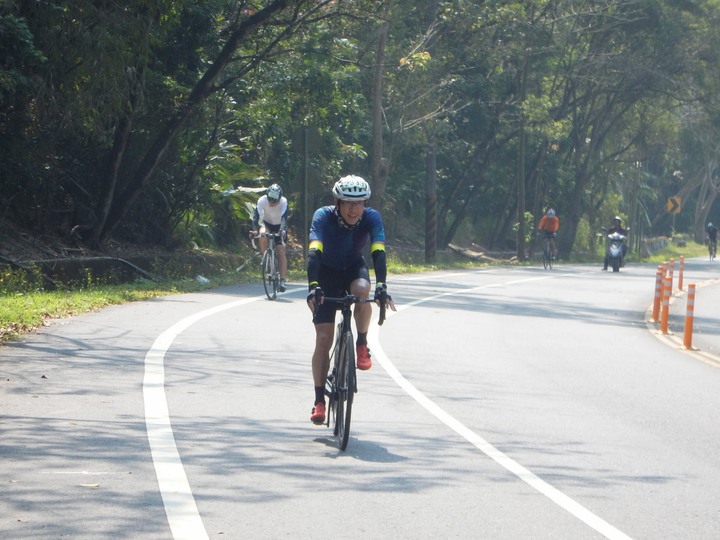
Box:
[307,175,395,425]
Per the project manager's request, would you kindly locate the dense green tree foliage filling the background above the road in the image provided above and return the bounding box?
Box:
[0,0,720,260]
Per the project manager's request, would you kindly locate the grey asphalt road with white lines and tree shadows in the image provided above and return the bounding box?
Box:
[0,260,720,539]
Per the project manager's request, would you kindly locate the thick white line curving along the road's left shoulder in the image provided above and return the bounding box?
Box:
[143,295,265,540]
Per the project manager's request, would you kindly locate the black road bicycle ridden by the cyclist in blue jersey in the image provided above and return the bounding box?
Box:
[323,293,387,450]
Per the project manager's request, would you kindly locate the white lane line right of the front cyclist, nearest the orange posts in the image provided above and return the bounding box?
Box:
[368,277,630,540]
